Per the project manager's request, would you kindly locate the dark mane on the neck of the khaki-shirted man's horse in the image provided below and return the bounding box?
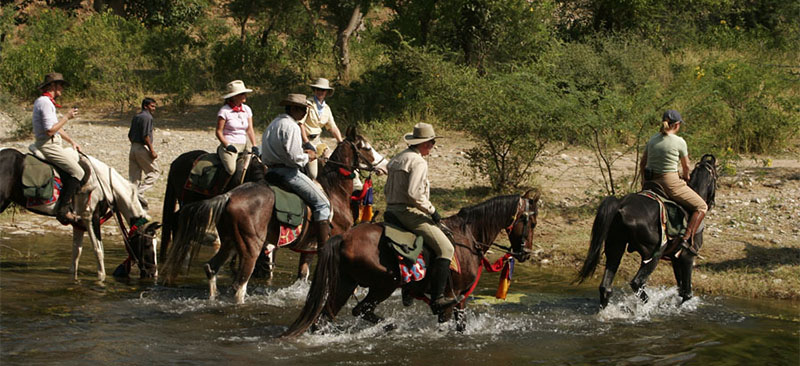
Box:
[447,194,520,243]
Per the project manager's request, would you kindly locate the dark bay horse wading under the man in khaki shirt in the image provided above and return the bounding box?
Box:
[282,191,539,337]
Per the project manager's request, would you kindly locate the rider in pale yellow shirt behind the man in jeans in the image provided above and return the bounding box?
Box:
[300,78,342,179]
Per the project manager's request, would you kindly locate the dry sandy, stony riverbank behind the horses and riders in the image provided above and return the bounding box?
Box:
[0,100,800,300]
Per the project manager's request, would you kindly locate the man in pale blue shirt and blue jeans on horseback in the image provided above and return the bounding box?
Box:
[261,94,331,249]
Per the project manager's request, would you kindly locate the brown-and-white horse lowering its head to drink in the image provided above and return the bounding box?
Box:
[0,148,159,281]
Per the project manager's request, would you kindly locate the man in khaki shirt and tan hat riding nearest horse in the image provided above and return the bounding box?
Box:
[384,123,459,314]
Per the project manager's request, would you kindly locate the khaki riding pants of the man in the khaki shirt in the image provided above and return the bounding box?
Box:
[386,205,455,261]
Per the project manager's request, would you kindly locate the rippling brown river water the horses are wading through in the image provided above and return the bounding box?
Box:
[0,235,800,366]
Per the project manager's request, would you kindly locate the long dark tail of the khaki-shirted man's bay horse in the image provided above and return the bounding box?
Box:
[281,235,343,337]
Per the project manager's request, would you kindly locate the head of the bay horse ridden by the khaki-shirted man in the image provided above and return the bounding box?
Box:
[506,190,539,262]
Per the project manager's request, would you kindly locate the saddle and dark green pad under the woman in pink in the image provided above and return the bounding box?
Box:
[184,152,249,196]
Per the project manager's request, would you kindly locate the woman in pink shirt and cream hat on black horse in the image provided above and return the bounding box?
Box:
[216,80,259,175]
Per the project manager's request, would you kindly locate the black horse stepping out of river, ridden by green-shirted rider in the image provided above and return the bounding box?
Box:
[577,154,717,308]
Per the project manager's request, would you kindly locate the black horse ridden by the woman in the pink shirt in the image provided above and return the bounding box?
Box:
[158,150,266,262]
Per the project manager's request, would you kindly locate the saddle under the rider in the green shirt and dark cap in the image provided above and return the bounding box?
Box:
[638,181,689,258]
